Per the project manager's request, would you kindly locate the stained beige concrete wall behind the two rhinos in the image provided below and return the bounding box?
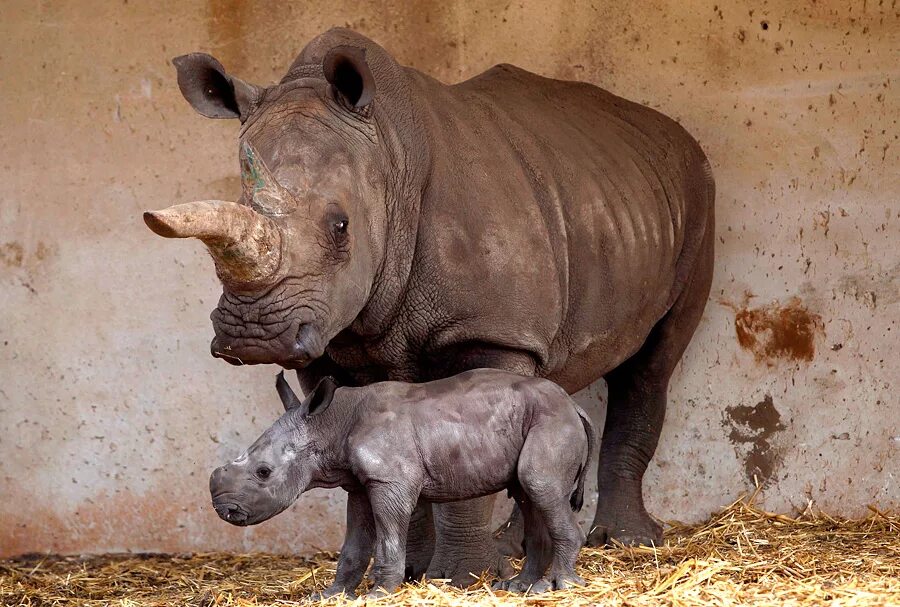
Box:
[0,0,900,554]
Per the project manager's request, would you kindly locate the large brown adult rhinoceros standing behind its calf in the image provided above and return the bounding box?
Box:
[145,29,714,583]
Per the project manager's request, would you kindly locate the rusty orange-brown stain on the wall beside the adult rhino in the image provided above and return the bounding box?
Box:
[720,297,824,365]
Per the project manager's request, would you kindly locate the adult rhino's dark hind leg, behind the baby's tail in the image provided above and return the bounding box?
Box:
[587,219,713,546]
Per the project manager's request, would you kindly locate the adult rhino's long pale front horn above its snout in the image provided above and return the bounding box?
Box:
[144,200,281,286]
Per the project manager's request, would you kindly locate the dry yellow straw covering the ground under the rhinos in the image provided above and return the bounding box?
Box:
[0,502,900,607]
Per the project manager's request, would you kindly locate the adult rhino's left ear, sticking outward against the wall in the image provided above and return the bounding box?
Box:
[172,53,261,122]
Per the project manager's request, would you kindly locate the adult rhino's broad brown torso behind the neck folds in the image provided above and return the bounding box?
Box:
[408,65,713,391]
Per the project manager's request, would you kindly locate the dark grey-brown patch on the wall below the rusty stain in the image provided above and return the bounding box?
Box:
[722,394,784,485]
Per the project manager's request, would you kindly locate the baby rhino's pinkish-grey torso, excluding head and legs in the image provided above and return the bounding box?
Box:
[354,369,581,502]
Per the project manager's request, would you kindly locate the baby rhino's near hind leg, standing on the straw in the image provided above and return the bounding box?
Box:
[518,422,585,593]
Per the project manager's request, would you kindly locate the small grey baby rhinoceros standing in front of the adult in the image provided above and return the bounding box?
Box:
[209,369,596,598]
